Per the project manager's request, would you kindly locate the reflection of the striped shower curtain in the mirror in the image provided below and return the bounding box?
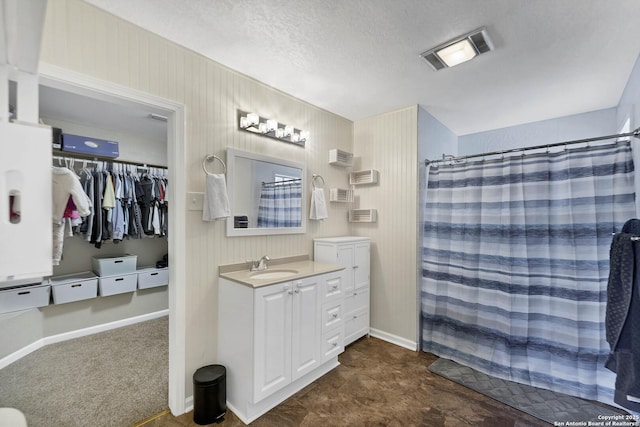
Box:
[258,181,302,227]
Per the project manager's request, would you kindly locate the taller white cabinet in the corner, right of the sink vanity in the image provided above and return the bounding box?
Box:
[313,236,371,345]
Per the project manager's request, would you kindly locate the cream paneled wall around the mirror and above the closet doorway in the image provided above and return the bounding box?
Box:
[41,0,353,396]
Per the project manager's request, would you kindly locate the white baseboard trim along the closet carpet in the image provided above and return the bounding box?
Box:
[0,309,169,369]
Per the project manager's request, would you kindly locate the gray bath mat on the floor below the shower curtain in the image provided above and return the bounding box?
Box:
[429,359,626,425]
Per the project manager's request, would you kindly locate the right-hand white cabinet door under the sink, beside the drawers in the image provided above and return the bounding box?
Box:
[291,276,324,380]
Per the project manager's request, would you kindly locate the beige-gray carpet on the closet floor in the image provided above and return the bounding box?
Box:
[0,317,169,427]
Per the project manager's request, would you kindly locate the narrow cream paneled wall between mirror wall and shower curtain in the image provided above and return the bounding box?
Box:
[352,106,418,347]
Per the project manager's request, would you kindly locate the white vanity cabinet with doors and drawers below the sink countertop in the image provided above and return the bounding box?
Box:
[217,271,344,423]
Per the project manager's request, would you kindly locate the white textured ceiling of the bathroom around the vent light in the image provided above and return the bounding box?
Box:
[86,0,640,135]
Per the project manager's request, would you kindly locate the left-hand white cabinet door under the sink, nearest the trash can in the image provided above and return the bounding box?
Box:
[253,282,294,402]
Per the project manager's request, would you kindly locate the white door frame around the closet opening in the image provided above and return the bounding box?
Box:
[39,62,186,415]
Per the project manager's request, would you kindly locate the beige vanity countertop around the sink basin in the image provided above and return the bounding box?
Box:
[219,255,344,288]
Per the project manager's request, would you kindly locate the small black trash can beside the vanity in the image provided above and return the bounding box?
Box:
[193,365,227,425]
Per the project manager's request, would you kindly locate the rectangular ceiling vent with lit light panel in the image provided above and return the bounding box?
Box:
[420,27,493,71]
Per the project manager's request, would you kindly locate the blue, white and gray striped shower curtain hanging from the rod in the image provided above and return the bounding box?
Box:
[421,143,635,403]
